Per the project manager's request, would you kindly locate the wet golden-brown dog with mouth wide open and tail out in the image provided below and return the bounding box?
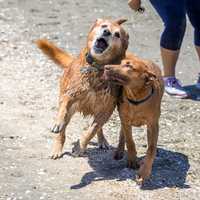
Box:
[37,19,128,159]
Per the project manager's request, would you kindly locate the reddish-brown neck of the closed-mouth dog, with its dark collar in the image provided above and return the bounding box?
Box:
[123,86,154,105]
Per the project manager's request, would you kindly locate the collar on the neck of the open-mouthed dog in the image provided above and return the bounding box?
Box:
[80,52,104,74]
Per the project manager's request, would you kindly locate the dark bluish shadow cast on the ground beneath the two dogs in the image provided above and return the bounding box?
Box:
[71,145,190,190]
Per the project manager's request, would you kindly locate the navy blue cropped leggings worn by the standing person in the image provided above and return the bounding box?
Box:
[150,0,200,50]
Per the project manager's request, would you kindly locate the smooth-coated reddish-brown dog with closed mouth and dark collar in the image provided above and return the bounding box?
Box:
[104,54,164,183]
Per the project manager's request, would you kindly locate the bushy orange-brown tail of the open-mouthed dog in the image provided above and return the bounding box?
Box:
[36,39,73,68]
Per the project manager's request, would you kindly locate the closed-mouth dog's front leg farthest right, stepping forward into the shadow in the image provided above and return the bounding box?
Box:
[137,122,159,184]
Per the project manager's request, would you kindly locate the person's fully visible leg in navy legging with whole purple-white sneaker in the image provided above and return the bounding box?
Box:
[150,0,187,97]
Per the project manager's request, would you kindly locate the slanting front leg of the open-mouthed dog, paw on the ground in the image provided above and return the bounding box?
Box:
[72,112,112,156]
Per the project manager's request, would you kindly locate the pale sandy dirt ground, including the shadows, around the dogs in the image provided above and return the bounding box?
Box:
[0,0,200,200]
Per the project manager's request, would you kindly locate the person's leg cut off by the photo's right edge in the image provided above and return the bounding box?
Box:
[186,0,200,89]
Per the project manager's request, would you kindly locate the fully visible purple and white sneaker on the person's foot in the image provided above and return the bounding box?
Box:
[163,76,188,98]
